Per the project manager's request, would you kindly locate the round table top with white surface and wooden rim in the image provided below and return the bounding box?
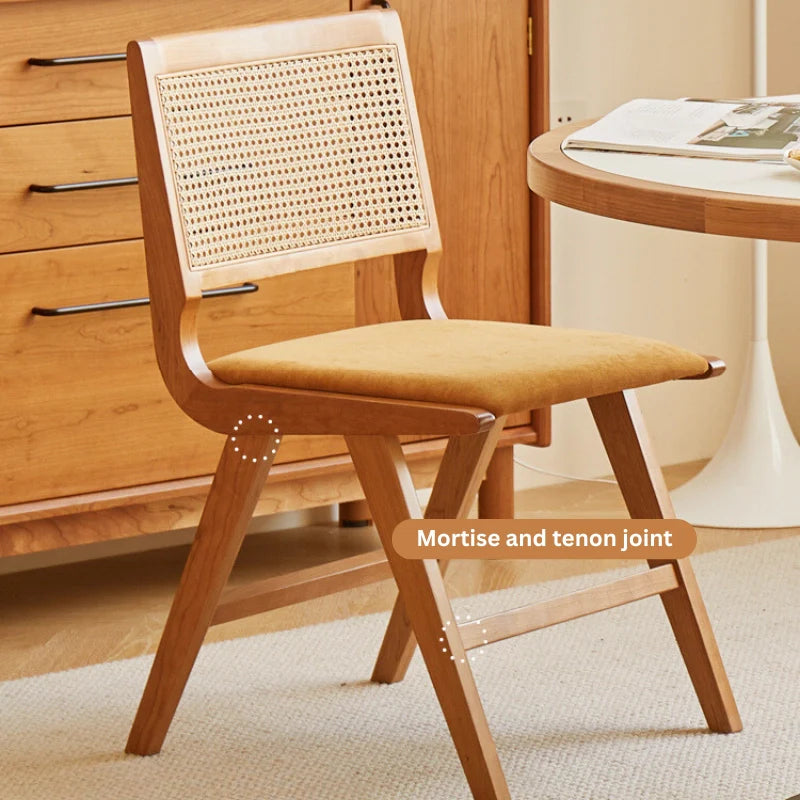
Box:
[528,122,800,242]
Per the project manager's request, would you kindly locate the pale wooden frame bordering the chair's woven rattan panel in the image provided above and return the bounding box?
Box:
[129,10,441,297]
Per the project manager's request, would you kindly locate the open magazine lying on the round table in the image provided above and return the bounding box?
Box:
[563,95,800,161]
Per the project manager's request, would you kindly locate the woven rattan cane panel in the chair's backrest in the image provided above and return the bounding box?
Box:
[157,45,428,269]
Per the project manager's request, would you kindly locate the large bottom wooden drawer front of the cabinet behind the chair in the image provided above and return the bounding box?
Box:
[0,241,354,505]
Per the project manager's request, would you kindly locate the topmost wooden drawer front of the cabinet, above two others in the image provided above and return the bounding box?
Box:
[0,0,350,125]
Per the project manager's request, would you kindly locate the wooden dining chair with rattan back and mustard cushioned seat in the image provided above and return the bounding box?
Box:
[127,10,741,800]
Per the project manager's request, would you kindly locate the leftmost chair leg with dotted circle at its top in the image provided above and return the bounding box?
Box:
[125,435,278,756]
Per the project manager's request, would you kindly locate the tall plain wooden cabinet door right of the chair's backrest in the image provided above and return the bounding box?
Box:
[352,0,549,443]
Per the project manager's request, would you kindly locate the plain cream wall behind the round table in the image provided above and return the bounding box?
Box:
[517,0,800,488]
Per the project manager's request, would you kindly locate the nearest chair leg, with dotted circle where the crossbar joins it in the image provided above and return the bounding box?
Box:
[347,436,510,800]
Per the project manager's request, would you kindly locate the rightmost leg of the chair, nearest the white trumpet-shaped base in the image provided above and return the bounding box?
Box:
[589,391,742,733]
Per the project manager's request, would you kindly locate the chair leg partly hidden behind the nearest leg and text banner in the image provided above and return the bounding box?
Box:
[372,419,504,683]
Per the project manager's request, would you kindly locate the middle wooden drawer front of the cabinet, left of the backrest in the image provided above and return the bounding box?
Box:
[0,117,142,253]
